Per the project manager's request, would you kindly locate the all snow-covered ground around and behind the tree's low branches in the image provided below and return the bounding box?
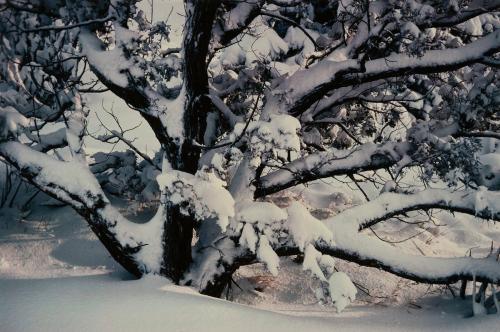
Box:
[0,183,500,332]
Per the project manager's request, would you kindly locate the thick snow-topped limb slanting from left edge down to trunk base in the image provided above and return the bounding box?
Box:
[0,141,163,276]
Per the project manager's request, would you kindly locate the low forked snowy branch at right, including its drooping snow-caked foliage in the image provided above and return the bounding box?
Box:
[250,188,500,310]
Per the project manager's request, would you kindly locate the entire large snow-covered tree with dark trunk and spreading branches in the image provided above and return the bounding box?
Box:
[0,0,500,310]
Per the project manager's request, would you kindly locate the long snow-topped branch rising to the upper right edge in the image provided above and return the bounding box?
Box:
[266,30,500,114]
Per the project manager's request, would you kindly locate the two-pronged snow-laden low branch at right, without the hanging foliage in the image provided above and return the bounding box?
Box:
[315,189,500,284]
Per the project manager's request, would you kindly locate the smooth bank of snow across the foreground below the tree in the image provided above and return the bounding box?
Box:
[0,274,499,332]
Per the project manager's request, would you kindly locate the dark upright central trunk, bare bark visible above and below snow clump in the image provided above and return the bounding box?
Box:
[156,0,219,283]
